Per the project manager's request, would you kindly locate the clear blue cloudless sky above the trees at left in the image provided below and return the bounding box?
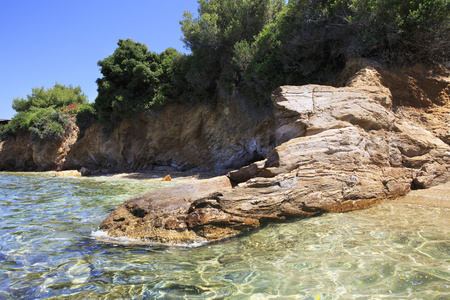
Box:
[0,0,198,119]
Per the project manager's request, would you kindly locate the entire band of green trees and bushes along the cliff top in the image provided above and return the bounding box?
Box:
[0,0,450,133]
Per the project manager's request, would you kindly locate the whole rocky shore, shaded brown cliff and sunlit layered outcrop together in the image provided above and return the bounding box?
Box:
[0,62,450,244]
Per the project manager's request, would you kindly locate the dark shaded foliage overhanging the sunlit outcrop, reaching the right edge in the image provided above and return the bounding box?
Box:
[241,0,450,99]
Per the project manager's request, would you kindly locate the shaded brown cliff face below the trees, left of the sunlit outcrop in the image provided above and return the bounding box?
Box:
[65,95,275,171]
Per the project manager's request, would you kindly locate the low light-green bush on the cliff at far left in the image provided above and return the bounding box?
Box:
[0,83,88,141]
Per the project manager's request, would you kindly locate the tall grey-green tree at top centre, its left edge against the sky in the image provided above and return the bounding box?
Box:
[180,0,284,94]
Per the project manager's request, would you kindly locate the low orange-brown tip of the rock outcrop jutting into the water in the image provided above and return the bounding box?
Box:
[100,176,231,244]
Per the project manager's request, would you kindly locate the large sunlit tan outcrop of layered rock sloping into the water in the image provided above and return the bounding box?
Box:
[100,68,450,243]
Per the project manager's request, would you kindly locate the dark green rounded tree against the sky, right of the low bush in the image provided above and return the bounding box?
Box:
[95,39,181,122]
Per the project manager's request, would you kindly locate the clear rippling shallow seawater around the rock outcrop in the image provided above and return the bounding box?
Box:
[0,173,450,299]
